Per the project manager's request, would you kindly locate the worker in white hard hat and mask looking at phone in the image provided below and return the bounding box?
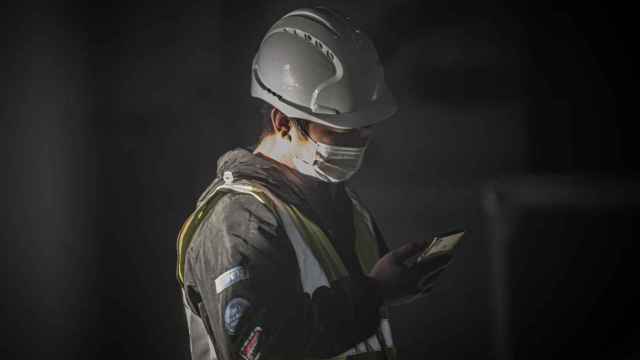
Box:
[178,8,449,360]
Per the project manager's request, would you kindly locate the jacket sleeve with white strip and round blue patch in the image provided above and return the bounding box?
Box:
[186,193,382,360]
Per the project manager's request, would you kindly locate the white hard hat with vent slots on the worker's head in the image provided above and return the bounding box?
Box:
[251,8,397,129]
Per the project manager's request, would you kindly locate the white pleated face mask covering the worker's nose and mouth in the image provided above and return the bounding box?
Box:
[293,126,367,183]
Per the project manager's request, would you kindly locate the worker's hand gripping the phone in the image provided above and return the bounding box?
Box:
[369,241,451,305]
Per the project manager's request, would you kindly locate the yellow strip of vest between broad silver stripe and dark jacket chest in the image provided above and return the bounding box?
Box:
[285,204,348,282]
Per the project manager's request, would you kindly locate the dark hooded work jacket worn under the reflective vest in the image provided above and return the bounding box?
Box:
[183,149,388,360]
